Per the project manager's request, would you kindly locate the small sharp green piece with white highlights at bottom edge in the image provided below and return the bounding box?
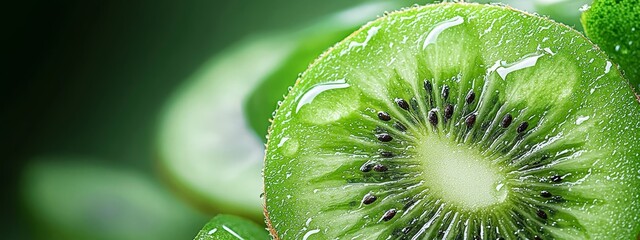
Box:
[194,214,270,240]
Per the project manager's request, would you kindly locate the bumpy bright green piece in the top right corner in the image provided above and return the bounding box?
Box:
[581,0,640,90]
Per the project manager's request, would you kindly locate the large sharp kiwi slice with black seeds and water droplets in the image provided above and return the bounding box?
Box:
[264,3,640,239]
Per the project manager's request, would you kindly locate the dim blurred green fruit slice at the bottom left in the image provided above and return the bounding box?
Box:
[22,158,206,240]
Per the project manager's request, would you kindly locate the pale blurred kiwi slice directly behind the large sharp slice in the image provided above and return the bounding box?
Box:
[157,1,416,221]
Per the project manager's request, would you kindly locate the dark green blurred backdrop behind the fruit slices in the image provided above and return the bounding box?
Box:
[0,0,585,239]
